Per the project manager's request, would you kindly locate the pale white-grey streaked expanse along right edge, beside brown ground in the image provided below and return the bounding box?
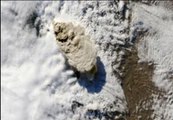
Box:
[132,4,173,120]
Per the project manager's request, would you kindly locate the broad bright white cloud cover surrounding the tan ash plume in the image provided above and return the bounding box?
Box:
[1,1,127,120]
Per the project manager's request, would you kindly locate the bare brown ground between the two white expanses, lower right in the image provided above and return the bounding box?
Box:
[120,37,162,120]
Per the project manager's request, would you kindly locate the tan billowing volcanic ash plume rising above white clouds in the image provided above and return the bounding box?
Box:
[54,22,97,79]
